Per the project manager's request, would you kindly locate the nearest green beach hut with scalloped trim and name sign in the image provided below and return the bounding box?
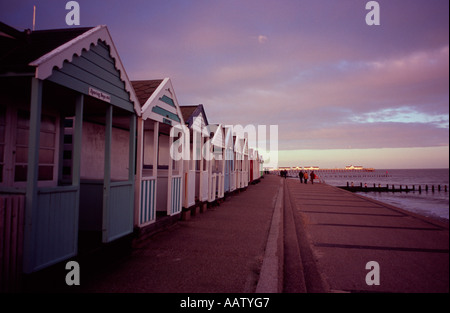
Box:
[0,23,139,273]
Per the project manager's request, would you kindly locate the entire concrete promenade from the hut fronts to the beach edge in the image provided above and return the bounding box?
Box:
[28,175,449,293]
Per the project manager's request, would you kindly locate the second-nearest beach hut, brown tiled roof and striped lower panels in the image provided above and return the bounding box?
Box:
[132,78,185,228]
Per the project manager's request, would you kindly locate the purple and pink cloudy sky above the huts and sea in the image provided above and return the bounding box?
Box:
[0,0,449,169]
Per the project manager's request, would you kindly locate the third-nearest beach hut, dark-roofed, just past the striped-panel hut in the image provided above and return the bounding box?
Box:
[180,104,209,209]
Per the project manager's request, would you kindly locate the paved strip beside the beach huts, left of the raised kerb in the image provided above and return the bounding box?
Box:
[80,175,282,293]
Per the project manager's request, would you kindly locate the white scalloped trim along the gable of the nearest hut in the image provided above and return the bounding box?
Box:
[29,25,140,115]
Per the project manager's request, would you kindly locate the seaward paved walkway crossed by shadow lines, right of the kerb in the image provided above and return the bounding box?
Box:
[285,179,449,293]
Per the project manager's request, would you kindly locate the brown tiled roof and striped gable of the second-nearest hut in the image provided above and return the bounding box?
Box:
[132,77,184,125]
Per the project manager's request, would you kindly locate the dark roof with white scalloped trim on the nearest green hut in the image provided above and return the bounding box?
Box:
[0,23,139,114]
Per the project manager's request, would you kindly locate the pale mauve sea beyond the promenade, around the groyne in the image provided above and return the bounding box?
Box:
[288,168,449,221]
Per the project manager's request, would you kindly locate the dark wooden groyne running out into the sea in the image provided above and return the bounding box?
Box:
[339,182,447,193]
